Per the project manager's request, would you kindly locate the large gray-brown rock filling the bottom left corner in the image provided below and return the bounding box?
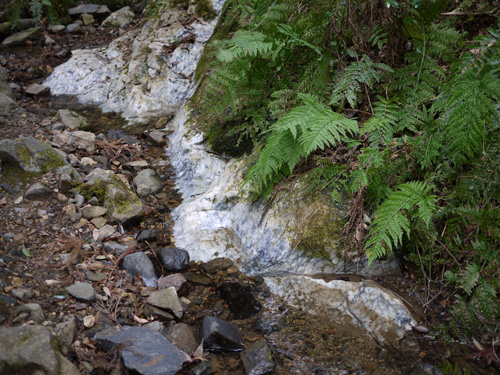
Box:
[0,325,79,375]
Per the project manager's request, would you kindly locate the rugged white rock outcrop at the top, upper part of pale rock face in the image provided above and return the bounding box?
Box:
[44,0,224,120]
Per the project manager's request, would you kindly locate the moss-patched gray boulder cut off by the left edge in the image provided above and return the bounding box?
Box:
[0,137,67,173]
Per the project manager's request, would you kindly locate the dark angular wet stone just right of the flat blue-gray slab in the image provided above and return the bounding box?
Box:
[201,316,244,351]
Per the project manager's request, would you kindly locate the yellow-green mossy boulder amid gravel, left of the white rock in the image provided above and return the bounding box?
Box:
[82,168,144,223]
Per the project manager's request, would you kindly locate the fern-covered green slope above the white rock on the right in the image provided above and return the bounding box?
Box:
[195,0,500,356]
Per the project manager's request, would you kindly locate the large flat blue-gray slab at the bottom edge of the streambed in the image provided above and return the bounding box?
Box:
[95,327,188,375]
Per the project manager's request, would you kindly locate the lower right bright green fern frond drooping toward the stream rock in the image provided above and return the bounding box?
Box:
[365,181,436,264]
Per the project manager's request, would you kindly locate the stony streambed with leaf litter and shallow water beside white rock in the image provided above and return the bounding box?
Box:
[0,2,496,375]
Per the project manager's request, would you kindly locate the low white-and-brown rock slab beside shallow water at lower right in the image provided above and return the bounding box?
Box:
[265,275,416,347]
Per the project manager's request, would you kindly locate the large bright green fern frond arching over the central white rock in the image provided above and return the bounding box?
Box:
[247,94,358,194]
